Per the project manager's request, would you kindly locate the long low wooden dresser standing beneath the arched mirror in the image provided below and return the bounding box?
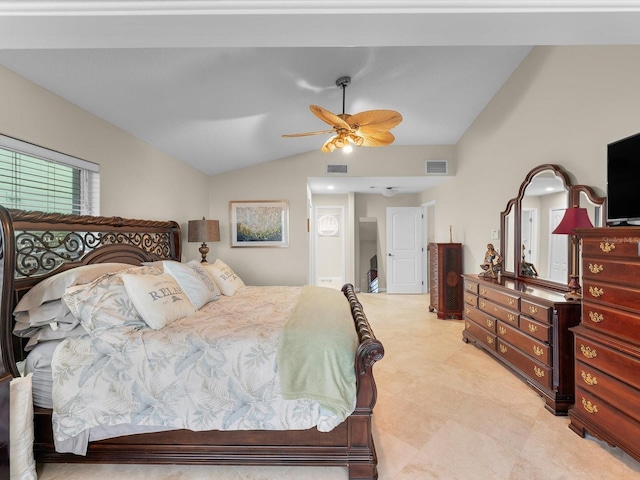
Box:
[462,275,580,415]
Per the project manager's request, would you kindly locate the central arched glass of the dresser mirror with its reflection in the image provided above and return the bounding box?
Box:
[520,170,569,284]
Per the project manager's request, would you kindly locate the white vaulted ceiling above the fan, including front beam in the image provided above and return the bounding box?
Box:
[0,0,640,193]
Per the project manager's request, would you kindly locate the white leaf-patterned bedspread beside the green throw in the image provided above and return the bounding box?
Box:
[52,287,355,454]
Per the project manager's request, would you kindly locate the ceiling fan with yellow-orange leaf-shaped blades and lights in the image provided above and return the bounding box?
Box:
[282,77,402,153]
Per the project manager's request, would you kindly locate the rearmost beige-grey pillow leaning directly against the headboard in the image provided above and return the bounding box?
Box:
[13,263,133,313]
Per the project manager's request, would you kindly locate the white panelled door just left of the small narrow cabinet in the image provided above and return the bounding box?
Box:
[387,207,422,293]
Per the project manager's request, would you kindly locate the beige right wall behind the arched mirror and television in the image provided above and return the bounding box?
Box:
[421,46,640,273]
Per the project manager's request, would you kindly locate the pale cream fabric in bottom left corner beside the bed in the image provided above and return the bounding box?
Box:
[9,373,38,480]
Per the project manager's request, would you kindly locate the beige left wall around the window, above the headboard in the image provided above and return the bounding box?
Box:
[0,67,208,258]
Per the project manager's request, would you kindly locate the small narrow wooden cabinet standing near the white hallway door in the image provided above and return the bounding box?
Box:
[428,243,463,319]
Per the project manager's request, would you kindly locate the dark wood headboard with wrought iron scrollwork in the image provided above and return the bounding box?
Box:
[0,205,181,376]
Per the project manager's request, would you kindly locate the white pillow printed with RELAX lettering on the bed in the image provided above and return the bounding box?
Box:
[122,273,196,330]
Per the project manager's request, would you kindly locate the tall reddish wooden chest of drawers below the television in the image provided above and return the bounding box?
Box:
[569,227,640,461]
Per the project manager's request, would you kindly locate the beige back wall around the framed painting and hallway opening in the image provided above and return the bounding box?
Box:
[210,145,455,285]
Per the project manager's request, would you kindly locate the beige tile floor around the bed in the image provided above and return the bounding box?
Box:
[38,294,640,480]
